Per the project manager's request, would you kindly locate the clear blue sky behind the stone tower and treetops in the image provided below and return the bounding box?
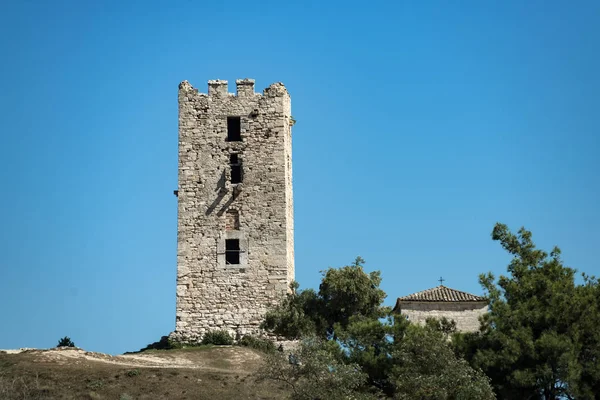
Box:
[0,0,600,353]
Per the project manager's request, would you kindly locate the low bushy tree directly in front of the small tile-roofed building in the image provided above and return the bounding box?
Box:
[337,316,495,400]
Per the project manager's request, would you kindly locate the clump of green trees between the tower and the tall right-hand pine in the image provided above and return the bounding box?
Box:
[263,257,494,400]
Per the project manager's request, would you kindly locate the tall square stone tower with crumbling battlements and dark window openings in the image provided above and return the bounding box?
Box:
[171,79,294,342]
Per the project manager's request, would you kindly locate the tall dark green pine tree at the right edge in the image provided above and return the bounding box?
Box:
[454,224,600,399]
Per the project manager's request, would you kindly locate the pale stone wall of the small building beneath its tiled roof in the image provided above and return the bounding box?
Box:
[400,301,488,332]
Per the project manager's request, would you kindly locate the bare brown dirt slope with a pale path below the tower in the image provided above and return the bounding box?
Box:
[0,346,286,400]
